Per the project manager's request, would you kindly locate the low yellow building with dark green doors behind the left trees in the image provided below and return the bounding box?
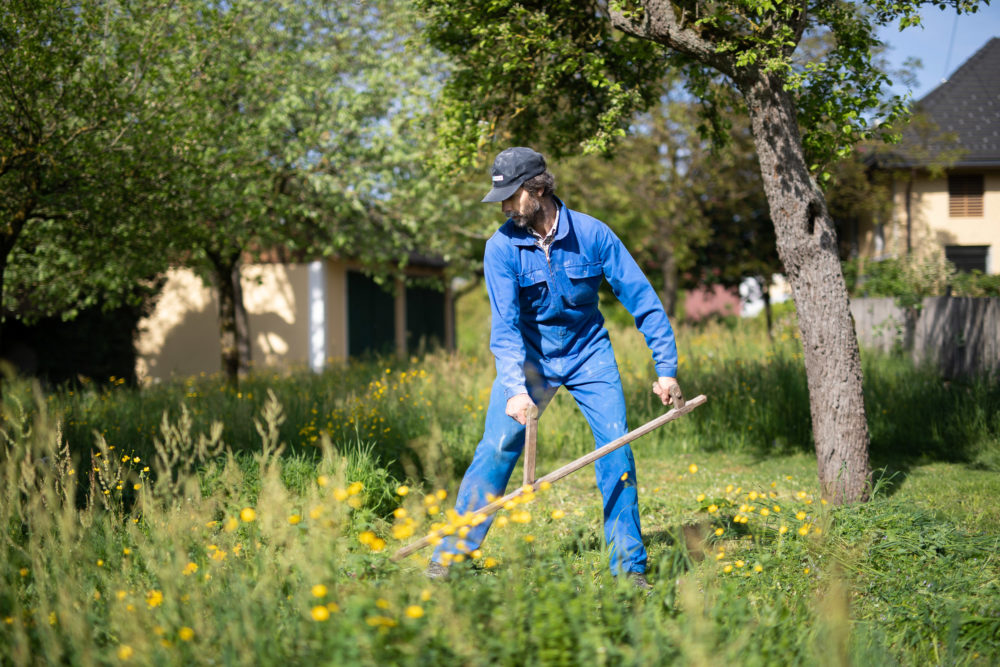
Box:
[135,258,455,383]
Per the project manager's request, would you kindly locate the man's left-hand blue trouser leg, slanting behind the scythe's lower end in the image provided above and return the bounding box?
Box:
[432,381,554,563]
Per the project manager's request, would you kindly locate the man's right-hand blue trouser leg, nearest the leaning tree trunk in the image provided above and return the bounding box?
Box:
[566,346,647,575]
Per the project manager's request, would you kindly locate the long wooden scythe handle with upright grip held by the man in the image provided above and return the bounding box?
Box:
[392,394,708,561]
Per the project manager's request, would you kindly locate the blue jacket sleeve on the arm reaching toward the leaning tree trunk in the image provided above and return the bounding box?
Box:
[601,225,677,377]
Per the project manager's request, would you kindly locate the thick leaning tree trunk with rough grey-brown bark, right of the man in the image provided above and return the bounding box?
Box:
[741,74,871,503]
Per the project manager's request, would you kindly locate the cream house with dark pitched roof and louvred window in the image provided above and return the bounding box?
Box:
[852,38,1000,273]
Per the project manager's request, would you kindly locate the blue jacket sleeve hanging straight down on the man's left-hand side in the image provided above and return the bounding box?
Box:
[483,238,528,399]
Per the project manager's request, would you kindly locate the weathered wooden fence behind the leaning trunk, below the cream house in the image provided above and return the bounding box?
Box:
[851,296,1000,377]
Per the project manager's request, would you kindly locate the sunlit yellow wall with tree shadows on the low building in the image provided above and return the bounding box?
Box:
[136,261,347,382]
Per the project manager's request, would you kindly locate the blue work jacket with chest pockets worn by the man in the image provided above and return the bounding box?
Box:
[483,199,677,399]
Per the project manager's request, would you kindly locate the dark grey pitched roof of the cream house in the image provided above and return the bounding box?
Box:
[879,37,1000,167]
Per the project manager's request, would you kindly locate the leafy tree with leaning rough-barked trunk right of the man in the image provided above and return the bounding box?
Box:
[420,0,978,502]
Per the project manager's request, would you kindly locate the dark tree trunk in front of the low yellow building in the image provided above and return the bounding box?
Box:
[209,252,250,387]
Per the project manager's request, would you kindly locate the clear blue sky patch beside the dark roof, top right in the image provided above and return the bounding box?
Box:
[879,0,1000,100]
